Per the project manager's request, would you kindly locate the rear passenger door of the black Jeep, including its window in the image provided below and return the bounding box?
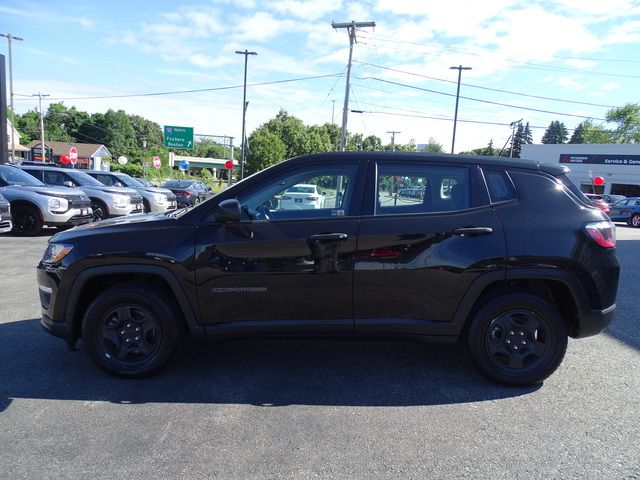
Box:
[354,159,506,335]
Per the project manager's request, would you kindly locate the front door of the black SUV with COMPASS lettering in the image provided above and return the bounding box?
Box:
[196,163,362,332]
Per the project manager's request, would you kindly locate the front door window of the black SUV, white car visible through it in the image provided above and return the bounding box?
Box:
[238,164,358,220]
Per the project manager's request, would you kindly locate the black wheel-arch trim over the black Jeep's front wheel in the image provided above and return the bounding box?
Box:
[64,264,202,343]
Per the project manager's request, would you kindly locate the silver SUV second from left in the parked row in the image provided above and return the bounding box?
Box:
[20,165,143,221]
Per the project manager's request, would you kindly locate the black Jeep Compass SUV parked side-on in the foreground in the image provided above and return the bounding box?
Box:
[38,152,619,385]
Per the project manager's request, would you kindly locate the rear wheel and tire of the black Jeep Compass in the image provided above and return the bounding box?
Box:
[465,292,568,386]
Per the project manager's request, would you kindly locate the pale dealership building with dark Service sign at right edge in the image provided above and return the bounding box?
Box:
[521,143,640,197]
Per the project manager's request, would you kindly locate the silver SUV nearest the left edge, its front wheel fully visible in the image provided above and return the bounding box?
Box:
[0,165,93,235]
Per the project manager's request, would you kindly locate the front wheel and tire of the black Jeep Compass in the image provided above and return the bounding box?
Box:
[82,283,182,378]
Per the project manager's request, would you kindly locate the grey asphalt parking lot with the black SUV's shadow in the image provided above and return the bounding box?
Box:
[0,224,640,479]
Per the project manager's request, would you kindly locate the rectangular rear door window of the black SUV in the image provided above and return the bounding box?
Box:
[376,163,470,215]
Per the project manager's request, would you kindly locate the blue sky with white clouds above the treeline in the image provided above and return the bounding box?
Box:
[0,0,640,151]
